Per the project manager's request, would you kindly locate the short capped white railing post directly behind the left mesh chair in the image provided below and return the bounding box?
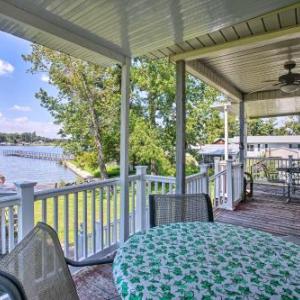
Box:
[15,181,36,239]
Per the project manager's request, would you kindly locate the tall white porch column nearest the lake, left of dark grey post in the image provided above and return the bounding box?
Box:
[120,57,131,243]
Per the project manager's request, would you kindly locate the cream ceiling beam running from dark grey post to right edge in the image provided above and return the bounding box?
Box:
[171,25,300,61]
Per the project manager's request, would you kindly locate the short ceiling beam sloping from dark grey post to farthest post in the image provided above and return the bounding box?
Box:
[186,60,242,102]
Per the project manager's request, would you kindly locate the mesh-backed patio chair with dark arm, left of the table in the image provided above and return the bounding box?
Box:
[0,223,113,300]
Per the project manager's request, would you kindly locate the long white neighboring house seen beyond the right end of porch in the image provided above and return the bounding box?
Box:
[229,135,300,158]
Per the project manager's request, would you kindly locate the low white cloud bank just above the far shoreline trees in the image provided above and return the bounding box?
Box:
[0,112,60,138]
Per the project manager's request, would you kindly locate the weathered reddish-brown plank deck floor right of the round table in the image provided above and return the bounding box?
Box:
[215,187,300,237]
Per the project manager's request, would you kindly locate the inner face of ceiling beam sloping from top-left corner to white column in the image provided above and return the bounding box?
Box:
[0,0,125,64]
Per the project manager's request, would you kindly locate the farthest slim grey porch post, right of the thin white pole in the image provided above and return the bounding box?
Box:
[239,97,247,197]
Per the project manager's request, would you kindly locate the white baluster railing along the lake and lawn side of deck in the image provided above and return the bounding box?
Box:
[0,165,243,260]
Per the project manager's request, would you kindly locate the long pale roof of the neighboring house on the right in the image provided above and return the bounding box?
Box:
[229,135,300,144]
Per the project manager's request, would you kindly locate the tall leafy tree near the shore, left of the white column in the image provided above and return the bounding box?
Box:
[23,45,120,178]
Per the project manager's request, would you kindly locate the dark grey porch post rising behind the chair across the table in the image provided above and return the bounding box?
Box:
[176,60,186,194]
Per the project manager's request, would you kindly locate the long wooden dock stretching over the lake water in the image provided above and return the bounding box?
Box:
[2,150,74,161]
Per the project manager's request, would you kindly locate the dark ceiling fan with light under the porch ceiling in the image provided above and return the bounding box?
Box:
[251,61,300,93]
